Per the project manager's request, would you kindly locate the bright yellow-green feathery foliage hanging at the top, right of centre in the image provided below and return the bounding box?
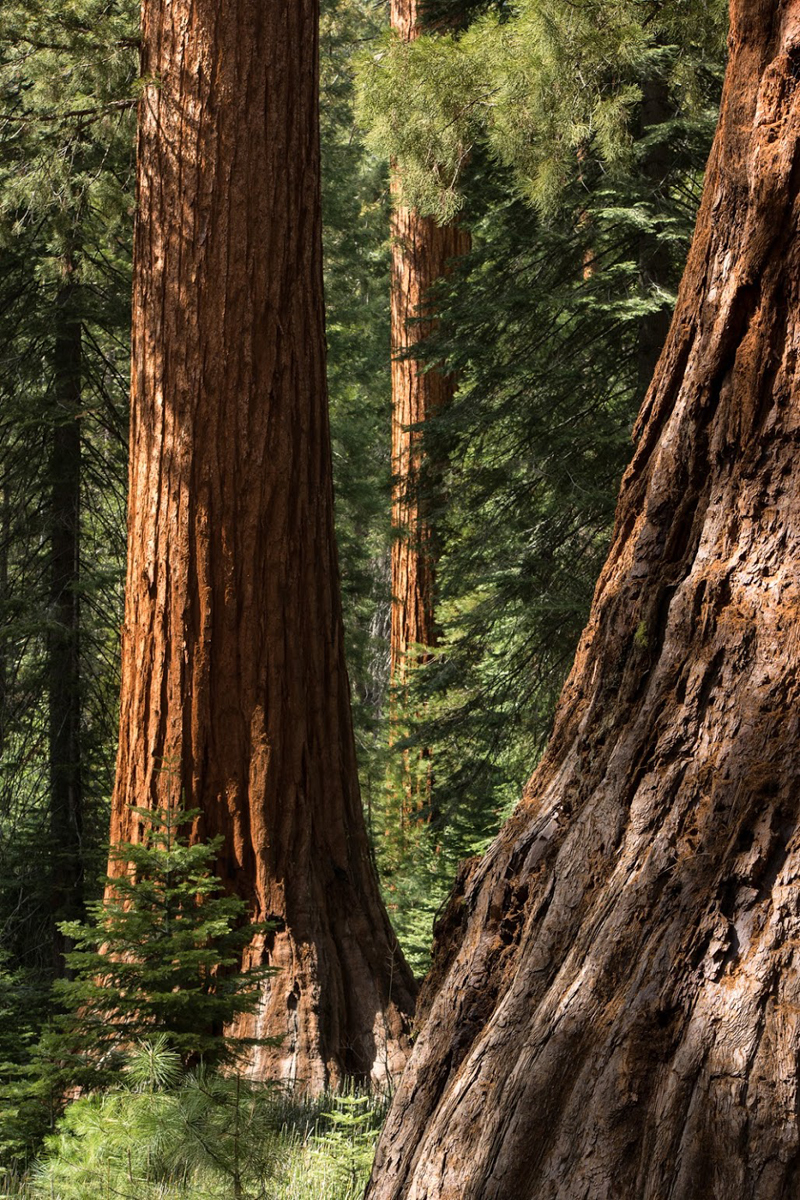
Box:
[359,0,727,220]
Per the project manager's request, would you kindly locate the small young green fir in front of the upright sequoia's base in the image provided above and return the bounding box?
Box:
[0,809,271,1165]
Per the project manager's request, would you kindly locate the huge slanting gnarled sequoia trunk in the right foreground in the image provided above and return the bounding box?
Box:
[368,0,800,1200]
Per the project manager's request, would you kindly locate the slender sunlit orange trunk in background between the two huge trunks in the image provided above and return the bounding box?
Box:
[391,0,470,684]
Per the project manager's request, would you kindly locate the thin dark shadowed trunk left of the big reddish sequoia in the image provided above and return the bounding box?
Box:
[47,267,83,974]
